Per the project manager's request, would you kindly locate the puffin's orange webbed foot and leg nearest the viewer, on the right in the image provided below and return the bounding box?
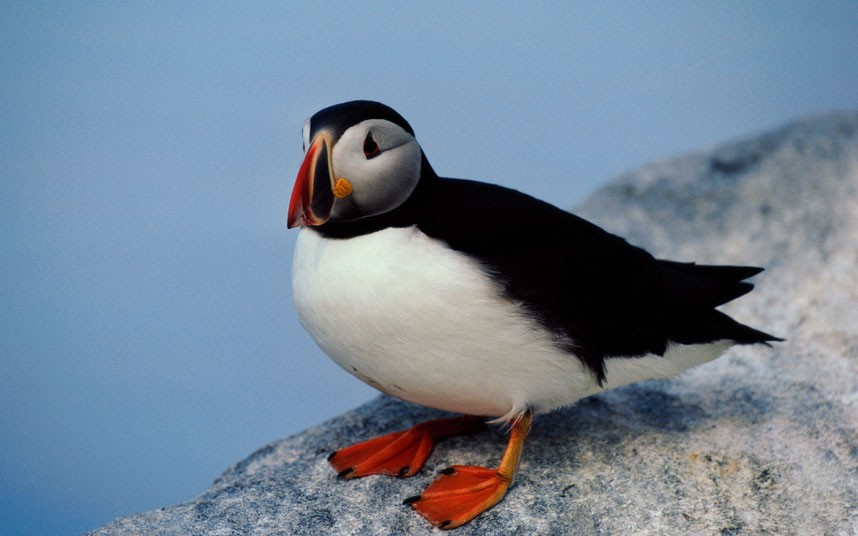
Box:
[405,412,533,529]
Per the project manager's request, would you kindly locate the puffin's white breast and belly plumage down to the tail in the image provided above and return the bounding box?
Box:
[292,227,729,420]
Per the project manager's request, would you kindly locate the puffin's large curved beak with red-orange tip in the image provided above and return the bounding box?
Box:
[287,133,334,229]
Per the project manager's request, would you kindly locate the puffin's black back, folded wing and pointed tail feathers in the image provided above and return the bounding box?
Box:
[415,179,777,382]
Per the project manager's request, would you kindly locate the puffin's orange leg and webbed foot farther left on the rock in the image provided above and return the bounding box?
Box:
[328,416,484,479]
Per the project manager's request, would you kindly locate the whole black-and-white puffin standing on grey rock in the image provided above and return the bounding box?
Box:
[287,100,782,529]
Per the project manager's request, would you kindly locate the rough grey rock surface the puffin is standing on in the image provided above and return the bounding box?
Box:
[92,113,858,536]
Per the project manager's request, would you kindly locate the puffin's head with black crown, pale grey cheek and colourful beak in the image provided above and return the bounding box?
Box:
[288,101,423,228]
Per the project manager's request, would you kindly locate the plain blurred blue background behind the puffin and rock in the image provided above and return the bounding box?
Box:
[0,2,858,534]
